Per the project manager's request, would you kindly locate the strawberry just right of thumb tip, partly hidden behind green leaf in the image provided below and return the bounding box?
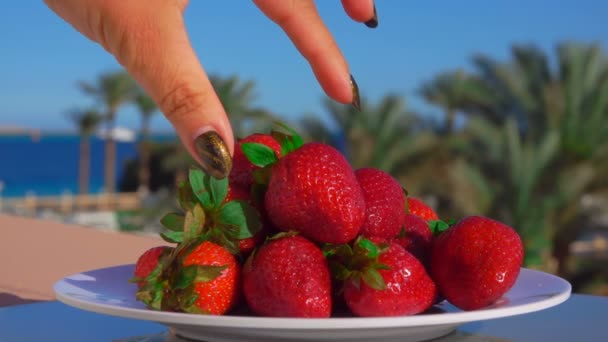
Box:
[228,133,281,192]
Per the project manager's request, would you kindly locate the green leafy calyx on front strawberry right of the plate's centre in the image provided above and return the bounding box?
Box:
[322,236,390,290]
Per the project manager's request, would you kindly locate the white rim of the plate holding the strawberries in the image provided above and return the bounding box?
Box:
[53,264,572,330]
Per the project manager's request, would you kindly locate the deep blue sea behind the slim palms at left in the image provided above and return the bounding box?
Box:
[0,135,175,197]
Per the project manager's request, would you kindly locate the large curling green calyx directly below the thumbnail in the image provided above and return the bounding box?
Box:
[160,168,262,254]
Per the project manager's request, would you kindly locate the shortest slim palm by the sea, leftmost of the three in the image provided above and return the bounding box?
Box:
[69,109,102,194]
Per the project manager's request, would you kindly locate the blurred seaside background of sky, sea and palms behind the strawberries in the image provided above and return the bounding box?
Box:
[0,0,608,295]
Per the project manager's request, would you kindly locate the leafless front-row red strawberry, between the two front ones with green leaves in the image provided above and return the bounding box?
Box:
[243,235,332,318]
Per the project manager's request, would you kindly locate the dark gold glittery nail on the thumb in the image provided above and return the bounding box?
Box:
[194,131,232,179]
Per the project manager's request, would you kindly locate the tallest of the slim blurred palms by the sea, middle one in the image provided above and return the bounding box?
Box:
[79,71,134,193]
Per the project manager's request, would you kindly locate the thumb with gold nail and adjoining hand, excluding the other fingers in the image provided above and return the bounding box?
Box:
[51,0,234,178]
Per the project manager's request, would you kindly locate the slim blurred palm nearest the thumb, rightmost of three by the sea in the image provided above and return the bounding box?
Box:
[133,87,158,194]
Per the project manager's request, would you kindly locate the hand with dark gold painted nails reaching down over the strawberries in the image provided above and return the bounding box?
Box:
[45,0,378,178]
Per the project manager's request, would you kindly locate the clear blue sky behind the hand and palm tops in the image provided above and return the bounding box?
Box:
[0,0,608,131]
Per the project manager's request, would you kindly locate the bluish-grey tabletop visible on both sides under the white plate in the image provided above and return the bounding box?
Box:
[0,295,608,342]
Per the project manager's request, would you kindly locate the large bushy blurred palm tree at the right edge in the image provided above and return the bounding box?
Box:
[434,44,608,276]
